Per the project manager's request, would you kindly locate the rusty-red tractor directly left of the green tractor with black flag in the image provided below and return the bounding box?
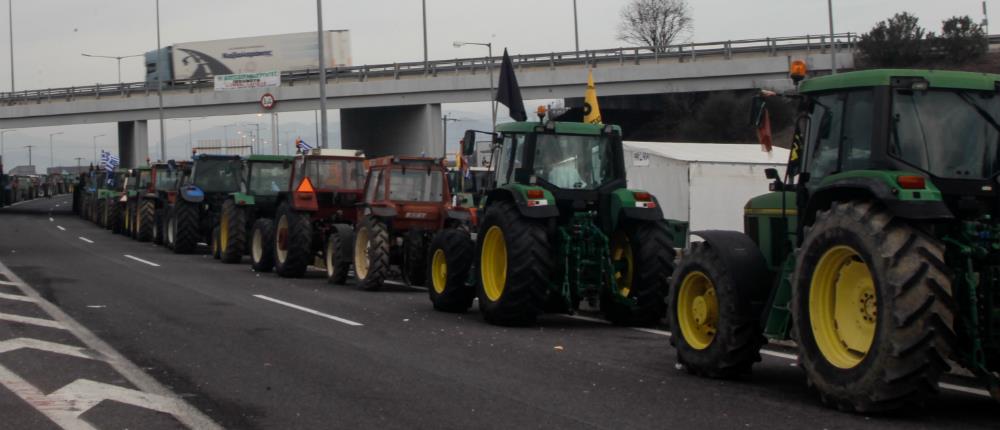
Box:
[354,157,473,290]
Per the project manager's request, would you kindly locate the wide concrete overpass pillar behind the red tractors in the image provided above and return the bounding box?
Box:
[340,104,444,157]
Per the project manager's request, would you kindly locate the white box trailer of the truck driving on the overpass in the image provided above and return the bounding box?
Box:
[173,30,351,80]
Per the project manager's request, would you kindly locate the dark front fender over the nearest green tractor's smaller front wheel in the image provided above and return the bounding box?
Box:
[691,230,771,306]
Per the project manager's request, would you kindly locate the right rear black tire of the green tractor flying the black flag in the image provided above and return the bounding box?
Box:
[601,221,677,326]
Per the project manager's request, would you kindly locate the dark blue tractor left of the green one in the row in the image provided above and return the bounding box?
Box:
[166,154,243,254]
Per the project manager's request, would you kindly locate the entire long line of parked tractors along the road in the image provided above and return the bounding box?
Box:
[64,65,1000,412]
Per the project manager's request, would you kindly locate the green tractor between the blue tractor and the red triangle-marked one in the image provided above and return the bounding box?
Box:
[213,155,295,264]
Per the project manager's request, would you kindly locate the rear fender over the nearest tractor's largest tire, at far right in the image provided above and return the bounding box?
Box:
[802,177,955,225]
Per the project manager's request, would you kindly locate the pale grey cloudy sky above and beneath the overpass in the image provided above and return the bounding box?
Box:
[0,0,988,171]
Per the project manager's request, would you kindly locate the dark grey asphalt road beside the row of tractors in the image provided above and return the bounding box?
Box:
[0,196,1000,429]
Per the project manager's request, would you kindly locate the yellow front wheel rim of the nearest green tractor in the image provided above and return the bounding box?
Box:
[676,271,719,350]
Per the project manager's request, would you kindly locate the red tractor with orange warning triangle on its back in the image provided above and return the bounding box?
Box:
[250,149,365,283]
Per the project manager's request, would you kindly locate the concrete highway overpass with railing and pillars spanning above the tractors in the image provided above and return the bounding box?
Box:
[0,33,857,165]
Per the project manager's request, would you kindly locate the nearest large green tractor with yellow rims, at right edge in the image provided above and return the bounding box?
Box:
[670,70,1000,412]
